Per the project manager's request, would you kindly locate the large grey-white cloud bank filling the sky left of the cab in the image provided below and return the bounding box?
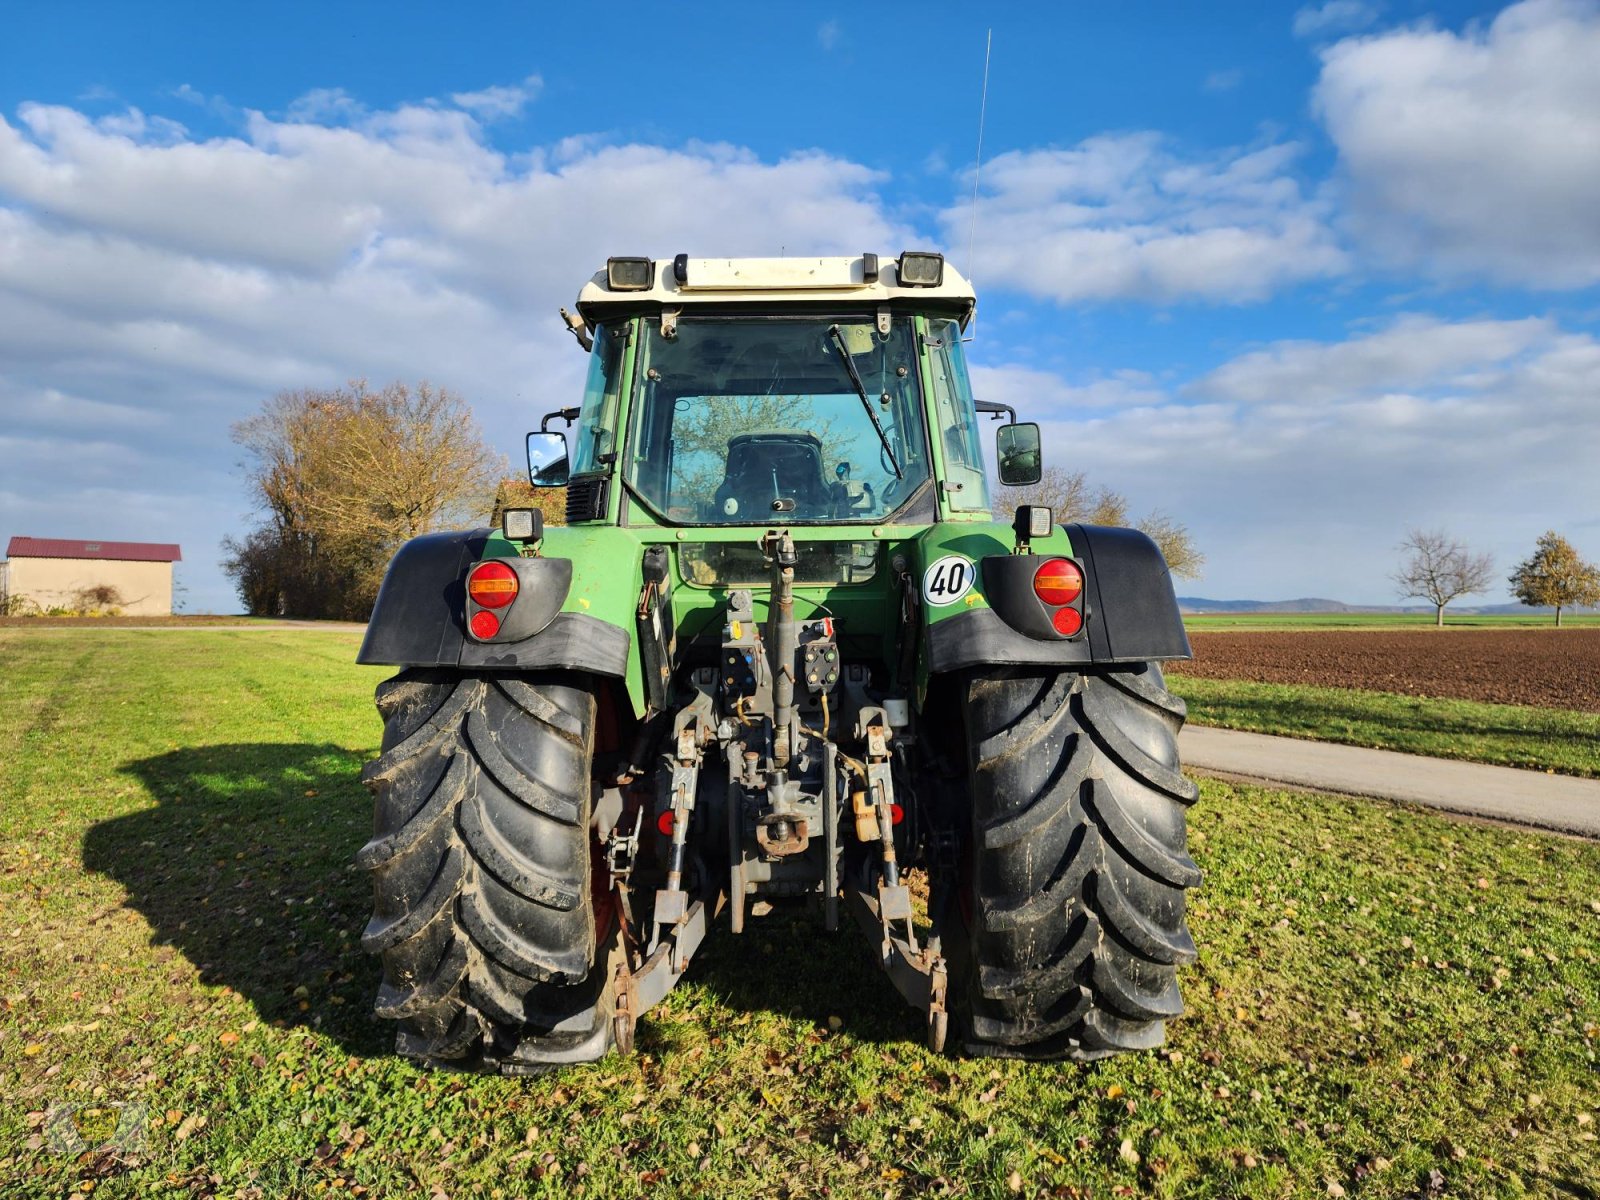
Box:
[0,91,910,608]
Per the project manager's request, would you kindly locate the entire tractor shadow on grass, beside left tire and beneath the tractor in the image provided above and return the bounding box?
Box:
[83,742,923,1056]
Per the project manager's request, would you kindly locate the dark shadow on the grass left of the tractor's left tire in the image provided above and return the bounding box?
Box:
[83,744,394,1056]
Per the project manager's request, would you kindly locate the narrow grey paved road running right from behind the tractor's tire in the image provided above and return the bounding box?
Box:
[1178,725,1600,838]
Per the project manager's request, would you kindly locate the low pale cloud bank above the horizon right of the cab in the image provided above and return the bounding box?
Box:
[974,315,1600,603]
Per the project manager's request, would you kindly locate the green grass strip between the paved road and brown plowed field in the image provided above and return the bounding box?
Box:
[1168,670,1600,776]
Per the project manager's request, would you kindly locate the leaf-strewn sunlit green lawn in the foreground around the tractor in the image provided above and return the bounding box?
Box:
[0,630,1600,1200]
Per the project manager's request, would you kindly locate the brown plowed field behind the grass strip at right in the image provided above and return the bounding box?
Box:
[1171,627,1600,712]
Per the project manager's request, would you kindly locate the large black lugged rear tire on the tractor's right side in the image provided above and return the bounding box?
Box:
[946,664,1200,1061]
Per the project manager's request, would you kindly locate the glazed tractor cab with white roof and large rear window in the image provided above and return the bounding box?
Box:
[530,254,1037,526]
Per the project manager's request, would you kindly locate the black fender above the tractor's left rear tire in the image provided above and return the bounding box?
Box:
[355,530,632,678]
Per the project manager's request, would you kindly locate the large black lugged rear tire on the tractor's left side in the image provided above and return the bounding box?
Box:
[355,669,610,1066]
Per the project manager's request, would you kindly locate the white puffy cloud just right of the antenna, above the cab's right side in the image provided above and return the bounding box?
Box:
[942,133,1346,304]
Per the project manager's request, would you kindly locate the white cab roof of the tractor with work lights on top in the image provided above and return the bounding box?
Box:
[578,254,978,326]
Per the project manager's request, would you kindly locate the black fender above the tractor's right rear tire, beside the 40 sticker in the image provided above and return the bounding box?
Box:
[928,525,1190,674]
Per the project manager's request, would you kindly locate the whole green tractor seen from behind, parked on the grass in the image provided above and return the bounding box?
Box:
[358,253,1200,1074]
